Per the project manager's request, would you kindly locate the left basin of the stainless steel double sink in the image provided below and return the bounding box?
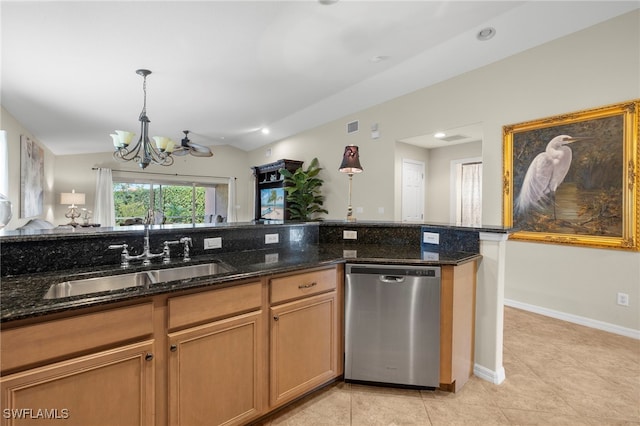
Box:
[44,272,157,299]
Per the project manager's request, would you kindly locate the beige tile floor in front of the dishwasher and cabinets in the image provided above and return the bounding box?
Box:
[255,308,640,426]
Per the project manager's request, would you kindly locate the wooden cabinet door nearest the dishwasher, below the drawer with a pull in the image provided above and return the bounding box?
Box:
[270,290,339,406]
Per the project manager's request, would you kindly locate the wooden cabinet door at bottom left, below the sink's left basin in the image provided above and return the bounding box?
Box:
[0,341,154,426]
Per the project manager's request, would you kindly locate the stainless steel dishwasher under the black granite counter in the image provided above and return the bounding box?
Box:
[345,264,440,388]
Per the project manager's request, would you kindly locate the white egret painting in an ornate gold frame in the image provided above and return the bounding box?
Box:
[503,100,640,250]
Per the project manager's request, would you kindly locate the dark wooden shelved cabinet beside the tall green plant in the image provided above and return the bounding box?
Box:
[251,160,303,220]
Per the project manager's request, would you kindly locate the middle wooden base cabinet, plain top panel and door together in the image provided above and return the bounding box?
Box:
[168,282,267,425]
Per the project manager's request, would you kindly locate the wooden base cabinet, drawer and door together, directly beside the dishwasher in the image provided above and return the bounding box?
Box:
[270,267,342,407]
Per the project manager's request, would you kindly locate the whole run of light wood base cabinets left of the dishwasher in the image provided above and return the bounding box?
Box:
[0,265,344,426]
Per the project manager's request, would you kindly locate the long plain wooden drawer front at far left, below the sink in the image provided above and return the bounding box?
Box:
[0,303,153,371]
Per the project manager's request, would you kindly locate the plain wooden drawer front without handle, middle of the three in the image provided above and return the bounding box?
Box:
[169,281,262,330]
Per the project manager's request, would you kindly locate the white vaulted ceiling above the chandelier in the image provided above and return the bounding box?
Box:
[0,0,640,155]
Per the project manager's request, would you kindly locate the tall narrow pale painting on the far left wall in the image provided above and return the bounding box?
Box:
[20,135,44,218]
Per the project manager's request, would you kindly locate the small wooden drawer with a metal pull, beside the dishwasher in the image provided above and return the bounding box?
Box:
[271,268,337,304]
